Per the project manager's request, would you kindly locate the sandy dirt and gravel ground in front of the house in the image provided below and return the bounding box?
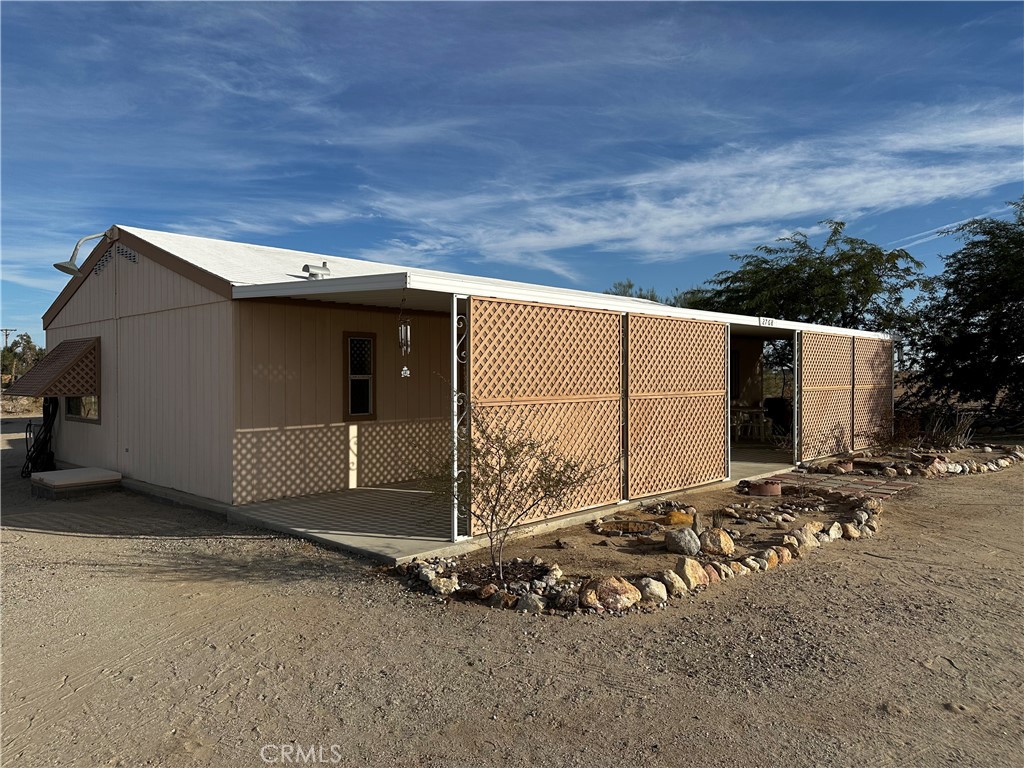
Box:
[6,419,1024,767]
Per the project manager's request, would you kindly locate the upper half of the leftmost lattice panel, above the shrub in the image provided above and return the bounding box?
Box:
[469,298,622,403]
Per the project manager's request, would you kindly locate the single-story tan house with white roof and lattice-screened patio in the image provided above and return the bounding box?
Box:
[9,225,893,539]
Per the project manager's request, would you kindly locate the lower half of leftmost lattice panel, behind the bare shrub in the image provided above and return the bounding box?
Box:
[472,397,622,535]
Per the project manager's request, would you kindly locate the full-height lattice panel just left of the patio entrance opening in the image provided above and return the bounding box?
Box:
[628,314,728,499]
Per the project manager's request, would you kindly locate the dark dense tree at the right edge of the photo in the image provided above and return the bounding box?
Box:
[910,197,1024,408]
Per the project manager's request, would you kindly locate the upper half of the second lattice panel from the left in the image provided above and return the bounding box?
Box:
[629,314,728,395]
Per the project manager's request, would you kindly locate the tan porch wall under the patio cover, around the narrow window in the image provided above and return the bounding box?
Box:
[232,301,451,504]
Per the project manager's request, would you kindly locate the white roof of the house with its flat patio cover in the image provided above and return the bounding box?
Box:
[118,224,890,339]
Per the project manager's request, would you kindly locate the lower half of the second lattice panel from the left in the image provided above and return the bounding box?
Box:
[629,392,726,499]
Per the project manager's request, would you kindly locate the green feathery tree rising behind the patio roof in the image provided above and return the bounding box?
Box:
[675,219,924,331]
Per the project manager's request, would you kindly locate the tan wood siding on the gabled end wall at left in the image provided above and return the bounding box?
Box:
[46,246,234,502]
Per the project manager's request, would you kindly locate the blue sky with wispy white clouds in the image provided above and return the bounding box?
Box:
[0,2,1024,339]
